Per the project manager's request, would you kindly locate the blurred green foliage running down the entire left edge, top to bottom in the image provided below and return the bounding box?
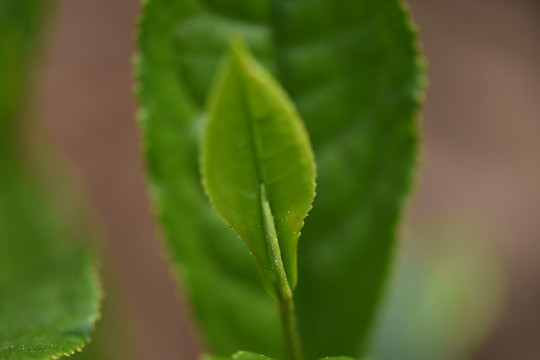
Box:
[0,0,100,360]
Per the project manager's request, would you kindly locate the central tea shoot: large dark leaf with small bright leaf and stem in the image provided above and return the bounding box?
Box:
[137,0,423,359]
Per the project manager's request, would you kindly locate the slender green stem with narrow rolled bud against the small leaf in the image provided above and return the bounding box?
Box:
[261,184,304,360]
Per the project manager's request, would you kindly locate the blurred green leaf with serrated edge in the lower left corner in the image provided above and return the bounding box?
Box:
[0,157,101,360]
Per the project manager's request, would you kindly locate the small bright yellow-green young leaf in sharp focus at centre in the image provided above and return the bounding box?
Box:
[201,42,315,295]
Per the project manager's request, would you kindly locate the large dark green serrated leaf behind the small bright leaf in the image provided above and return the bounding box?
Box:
[138,0,423,358]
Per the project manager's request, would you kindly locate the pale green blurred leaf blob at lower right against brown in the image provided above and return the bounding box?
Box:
[371,222,504,360]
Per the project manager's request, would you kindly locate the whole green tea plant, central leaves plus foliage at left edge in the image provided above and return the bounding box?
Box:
[0,0,423,360]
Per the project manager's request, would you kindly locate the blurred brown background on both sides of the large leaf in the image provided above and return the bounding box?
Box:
[32,0,540,360]
